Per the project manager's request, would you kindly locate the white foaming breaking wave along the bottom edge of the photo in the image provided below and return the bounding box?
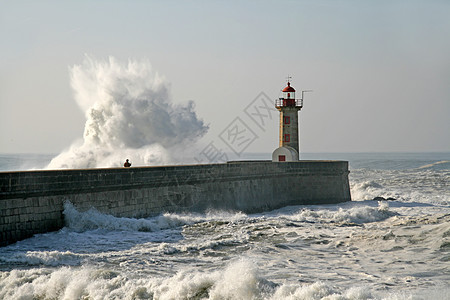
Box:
[0,258,440,300]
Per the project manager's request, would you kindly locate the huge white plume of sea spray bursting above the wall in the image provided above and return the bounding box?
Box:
[47,56,208,169]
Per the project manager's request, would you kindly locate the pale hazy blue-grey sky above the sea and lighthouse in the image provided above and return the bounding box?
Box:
[0,0,450,153]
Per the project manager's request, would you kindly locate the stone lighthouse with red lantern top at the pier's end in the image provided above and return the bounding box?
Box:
[272,80,303,162]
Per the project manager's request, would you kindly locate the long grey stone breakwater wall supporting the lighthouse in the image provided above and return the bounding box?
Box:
[0,161,351,246]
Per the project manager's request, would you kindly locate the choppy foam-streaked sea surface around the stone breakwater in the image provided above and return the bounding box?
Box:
[0,153,450,299]
